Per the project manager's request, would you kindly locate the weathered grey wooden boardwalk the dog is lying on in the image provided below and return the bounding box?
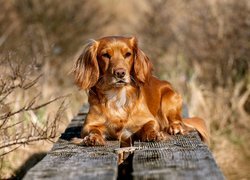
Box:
[24,108,224,180]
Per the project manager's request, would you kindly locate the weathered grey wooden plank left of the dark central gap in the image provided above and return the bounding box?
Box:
[24,107,119,180]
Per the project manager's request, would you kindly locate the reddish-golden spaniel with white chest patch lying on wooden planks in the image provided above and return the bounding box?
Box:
[73,36,208,146]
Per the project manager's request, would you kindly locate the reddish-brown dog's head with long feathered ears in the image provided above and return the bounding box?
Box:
[73,36,152,89]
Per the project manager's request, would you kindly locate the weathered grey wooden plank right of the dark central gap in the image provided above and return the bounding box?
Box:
[132,132,224,180]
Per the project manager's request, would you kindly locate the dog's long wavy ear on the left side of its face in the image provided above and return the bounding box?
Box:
[73,40,99,89]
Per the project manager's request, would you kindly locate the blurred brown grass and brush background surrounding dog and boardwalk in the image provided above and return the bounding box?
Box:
[0,0,250,179]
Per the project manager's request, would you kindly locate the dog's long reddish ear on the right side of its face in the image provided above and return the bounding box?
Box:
[131,37,153,84]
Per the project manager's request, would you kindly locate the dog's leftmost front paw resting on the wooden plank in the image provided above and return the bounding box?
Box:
[82,134,105,146]
